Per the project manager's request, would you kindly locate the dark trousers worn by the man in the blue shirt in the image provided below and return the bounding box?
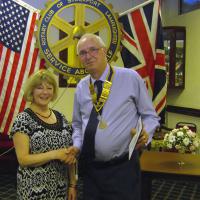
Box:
[83,152,141,200]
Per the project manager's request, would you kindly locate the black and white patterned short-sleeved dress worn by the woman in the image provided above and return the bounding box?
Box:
[11,108,72,200]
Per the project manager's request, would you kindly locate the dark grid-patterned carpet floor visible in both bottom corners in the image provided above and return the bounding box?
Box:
[0,169,200,200]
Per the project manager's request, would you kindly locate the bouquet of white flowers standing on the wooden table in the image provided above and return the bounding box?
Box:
[163,126,200,153]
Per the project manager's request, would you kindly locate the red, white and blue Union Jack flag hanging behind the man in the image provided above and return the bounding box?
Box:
[119,0,167,123]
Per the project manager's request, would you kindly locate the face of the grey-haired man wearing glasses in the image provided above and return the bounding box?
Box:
[78,38,106,73]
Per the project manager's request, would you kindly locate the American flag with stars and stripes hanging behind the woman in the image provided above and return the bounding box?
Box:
[0,0,43,134]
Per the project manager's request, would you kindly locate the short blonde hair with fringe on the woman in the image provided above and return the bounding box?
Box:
[24,69,58,102]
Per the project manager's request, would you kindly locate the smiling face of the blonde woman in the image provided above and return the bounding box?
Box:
[33,81,54,107]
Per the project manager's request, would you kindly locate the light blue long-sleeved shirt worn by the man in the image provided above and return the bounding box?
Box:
[72,66,160,161]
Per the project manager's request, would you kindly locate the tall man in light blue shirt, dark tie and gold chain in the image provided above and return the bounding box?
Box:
[72,34,159,200]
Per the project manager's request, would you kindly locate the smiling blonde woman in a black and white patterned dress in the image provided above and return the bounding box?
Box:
[11,69,76,200]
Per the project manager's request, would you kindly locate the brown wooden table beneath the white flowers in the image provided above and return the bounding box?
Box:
[140,151,200,200]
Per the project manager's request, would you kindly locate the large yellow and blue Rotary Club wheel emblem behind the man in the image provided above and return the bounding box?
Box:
[36,0,121,79]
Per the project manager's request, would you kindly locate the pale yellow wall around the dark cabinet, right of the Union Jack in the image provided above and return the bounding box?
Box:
[162,0,200,131]
